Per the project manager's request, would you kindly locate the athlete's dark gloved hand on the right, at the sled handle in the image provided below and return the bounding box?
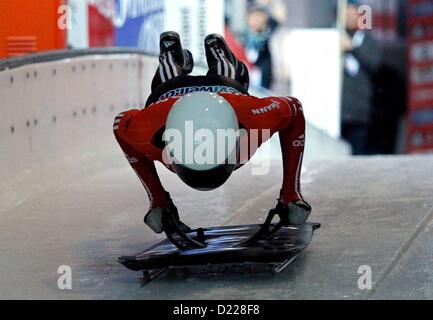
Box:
[273,200,312,227]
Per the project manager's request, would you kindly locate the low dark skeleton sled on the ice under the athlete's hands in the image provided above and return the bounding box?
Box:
[118,213,320,283]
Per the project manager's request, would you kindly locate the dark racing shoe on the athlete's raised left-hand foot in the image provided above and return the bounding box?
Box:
[159,31,194,74]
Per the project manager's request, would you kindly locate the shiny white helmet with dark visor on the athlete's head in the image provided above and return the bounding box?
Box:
[163,92,239,190]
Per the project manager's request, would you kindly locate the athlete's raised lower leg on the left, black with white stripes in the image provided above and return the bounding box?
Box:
[152,31,194,91]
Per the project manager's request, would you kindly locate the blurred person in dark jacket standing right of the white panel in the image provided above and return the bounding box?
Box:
[341,0,382,155]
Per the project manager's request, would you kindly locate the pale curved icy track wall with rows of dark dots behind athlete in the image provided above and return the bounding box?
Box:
[0,49,348,214]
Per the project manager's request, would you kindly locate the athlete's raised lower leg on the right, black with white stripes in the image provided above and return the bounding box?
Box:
[204,34,249,90]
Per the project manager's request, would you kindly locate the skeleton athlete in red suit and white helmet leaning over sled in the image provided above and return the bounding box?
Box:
[114,31,311,233]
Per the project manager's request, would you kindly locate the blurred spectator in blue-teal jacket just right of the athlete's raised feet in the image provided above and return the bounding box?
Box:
[244,5,278,89]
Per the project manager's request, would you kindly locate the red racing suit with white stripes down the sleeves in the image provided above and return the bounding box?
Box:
[113,93,305,208]
